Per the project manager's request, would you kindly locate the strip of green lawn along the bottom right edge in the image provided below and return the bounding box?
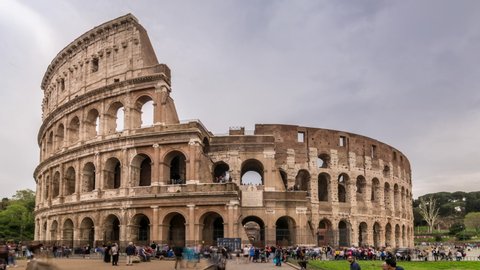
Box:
[308,260,480,270]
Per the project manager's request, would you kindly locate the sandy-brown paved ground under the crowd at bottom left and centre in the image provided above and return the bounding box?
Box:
[8,258,293,270]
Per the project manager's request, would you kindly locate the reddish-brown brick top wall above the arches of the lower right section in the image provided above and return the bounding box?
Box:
[255,124,411,176]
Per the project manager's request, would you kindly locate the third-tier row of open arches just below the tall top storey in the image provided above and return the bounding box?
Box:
[41,95,155,158]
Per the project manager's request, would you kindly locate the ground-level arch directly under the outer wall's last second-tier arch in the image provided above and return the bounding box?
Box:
[163,212,186,247]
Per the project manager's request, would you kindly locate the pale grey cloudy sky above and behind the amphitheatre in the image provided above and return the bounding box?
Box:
[0,0,480,197]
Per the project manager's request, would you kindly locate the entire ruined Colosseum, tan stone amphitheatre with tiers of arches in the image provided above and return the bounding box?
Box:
[34,14,413,250]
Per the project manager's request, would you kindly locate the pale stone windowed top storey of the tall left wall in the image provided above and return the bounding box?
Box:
[41,14,170,119]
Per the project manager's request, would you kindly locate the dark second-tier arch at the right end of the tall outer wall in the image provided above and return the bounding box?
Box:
[164,150,187,185]
